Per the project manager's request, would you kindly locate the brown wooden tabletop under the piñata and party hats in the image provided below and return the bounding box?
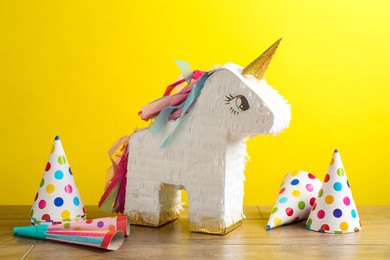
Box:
[0,206,390,260]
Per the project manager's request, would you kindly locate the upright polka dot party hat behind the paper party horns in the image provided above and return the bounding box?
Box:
[30,136,86,225]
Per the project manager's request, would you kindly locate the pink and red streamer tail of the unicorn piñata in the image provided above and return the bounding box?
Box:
[99,136,129,213]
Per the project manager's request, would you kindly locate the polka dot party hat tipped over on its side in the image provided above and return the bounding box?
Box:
[266,171,321,230]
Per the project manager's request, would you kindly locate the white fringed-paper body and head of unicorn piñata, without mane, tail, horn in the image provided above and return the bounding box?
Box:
[124,63,291,234]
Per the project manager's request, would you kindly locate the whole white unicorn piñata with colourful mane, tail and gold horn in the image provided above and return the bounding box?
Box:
[99,40,291,234]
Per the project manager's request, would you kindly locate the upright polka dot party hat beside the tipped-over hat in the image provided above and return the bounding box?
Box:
[306,149,362,234]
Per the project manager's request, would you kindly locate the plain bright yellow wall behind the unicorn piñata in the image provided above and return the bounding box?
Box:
[0,0,390,205]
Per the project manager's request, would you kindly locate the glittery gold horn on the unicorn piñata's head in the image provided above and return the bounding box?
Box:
[241,38,282,80]
